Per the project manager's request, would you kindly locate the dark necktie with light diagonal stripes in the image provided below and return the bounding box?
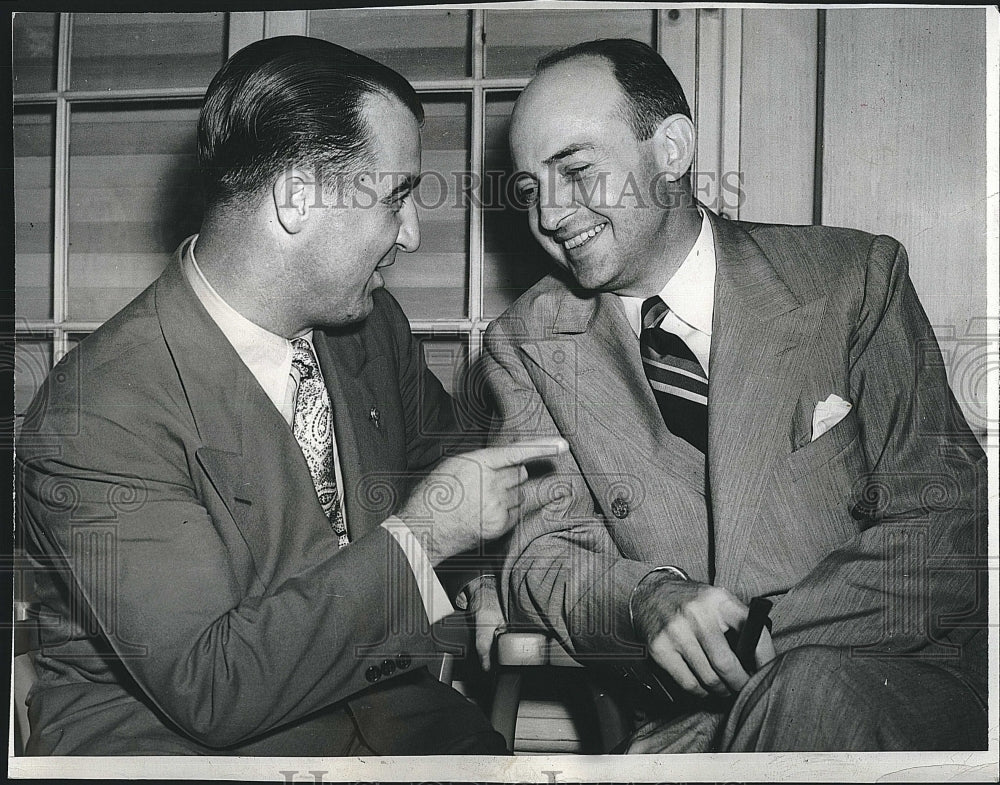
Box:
[639,296,708,452]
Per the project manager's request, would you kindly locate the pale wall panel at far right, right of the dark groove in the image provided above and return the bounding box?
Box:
[823,8,986,425]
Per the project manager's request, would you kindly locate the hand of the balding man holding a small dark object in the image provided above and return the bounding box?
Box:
[632,572,775,697]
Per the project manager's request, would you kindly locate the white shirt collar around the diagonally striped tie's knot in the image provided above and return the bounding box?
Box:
[621,210,716,336]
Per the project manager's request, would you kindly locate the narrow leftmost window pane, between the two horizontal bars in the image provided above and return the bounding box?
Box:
[14,108,55,319]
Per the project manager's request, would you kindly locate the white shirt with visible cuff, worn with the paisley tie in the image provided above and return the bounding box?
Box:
[181,235,453,624]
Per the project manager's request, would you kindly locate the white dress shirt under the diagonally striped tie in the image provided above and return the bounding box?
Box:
[621,211,715,376]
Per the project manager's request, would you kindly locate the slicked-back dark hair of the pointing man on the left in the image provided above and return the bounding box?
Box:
[198,36,424,207]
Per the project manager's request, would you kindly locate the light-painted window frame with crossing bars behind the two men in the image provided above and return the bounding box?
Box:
[14,11,742,402]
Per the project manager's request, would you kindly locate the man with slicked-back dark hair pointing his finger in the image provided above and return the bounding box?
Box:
[18,37,556,756]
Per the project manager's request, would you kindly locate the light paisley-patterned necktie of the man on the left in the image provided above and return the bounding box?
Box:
[292,338,350,548]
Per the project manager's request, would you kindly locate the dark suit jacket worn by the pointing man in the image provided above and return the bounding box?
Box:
[17,248,468,755]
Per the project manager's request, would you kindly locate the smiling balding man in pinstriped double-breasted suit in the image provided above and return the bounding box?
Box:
[486,40,987,752]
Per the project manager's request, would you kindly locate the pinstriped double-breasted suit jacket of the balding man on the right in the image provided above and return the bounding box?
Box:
[486,216,986,694]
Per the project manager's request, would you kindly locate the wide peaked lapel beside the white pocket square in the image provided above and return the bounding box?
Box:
[708,211,825,586]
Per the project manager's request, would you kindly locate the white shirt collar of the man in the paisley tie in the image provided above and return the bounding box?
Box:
[181,235,312,404]
